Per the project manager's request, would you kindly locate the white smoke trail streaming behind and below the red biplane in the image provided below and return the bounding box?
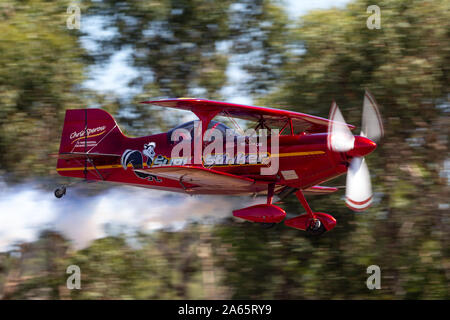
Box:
[0,182,264,251]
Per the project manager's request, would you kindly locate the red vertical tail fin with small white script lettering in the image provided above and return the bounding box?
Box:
[59,109,125,154]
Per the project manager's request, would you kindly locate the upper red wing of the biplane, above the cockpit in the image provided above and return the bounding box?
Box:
[142,98,355,133]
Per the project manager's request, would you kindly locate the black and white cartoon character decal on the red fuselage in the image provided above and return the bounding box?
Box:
[120,142,162,182]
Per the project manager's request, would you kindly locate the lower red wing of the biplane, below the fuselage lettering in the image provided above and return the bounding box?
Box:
[135,166,267,194]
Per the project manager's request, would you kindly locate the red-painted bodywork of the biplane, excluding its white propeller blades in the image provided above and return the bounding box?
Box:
[57,99,376,236]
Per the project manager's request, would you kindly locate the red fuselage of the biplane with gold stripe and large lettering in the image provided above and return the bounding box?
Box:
[57,133,348,194]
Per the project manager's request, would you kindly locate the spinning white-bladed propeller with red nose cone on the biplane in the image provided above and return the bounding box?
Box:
[328,91,383,211]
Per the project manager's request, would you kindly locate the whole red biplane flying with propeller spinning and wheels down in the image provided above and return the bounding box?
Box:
[55,92,383,235]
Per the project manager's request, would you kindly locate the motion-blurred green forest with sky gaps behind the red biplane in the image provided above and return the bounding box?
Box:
[0,0,450,299]
